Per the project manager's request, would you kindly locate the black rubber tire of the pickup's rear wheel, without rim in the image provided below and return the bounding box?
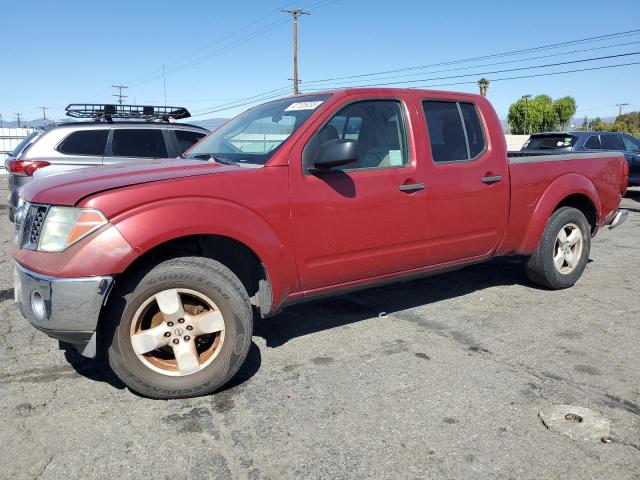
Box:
[525,207,591,290]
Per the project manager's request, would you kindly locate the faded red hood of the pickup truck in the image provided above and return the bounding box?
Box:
[20,159,242,206]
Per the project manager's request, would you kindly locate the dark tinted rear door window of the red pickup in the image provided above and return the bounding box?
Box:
[422,101,486,162]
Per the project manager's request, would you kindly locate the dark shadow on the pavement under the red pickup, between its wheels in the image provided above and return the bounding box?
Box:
[254,257,541,348]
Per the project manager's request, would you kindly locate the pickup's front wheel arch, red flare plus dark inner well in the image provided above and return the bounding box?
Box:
[113,197,298,315]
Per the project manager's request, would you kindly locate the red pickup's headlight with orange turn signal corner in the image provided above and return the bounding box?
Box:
[38,207,107,252]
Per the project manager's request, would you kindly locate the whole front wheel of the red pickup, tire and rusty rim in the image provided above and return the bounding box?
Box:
[107,257,253,399]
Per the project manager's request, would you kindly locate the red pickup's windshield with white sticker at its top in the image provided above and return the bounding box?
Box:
[186,95,329,166]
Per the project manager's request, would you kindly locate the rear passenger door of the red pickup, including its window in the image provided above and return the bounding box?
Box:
[421,99,509,265]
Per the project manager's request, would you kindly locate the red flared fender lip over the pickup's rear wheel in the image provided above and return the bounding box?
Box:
[518,173,602,254]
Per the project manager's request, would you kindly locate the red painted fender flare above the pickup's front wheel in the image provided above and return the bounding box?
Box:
[111,197,297,305]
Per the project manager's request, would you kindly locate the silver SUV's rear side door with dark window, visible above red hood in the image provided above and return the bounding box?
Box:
[104,126,169,165]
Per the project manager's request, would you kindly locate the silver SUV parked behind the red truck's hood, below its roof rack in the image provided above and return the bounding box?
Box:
[5,108,209,221]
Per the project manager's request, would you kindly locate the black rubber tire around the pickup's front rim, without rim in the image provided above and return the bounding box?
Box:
[106,257,253,399]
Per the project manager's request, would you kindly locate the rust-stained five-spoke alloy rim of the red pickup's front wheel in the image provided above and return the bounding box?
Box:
[130,288,225,376]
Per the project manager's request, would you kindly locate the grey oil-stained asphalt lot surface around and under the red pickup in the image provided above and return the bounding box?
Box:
[0,180,640,479]
